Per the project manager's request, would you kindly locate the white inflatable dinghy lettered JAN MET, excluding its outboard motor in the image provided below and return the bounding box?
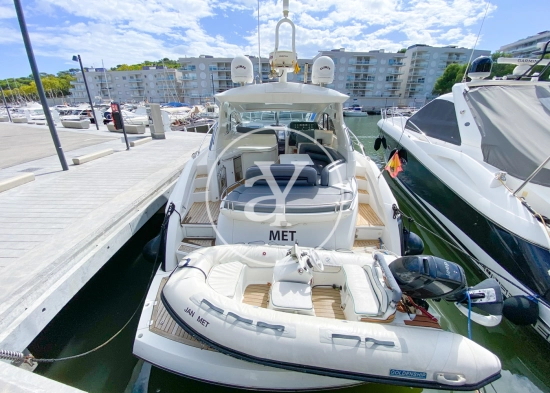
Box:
[162,245,501,390]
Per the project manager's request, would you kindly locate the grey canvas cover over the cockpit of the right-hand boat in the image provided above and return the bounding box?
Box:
[465,84,550,187]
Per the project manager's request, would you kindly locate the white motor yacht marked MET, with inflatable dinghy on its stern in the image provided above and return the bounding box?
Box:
[133,3,500,391]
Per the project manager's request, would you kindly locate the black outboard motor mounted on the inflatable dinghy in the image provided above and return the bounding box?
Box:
[390,255,503,326]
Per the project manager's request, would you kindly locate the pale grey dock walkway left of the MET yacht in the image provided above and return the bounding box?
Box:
[0,123,208,351]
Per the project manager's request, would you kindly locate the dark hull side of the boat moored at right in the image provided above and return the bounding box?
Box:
[382,130,550,342]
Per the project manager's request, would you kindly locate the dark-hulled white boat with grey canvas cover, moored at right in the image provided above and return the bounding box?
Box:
[375,52,550,341]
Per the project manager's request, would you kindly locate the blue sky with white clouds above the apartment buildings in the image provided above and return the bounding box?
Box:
[0,0,550,79]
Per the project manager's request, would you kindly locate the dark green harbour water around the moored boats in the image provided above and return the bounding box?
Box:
[30,116,550,393]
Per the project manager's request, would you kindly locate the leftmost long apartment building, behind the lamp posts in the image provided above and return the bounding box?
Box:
[70,66,183,103]
